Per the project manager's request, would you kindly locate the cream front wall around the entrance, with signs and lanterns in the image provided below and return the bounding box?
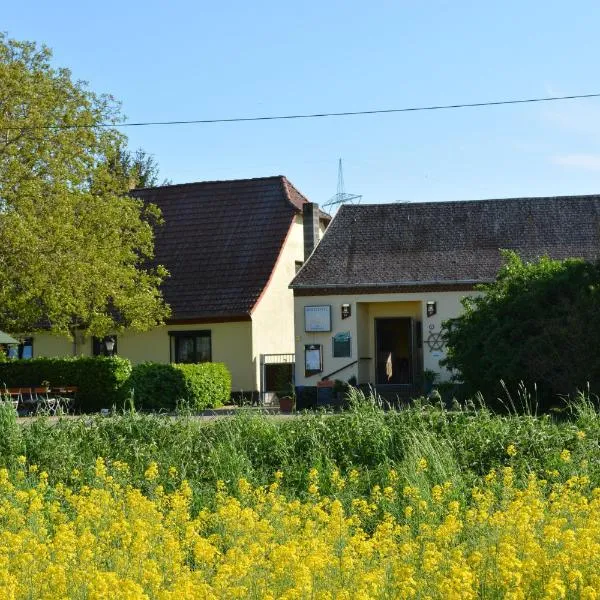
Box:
[294,292,473,386]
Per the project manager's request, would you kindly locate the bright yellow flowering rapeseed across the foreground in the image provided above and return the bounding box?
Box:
[0,454,600,600]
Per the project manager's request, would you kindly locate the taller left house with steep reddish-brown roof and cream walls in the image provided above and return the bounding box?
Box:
[24,176,330,394]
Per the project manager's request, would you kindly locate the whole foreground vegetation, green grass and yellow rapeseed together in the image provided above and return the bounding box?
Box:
[0,393,600,600]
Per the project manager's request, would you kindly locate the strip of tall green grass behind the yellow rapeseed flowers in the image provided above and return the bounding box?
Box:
[0,393,600,510]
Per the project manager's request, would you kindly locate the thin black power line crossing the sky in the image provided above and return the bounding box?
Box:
[0,93,600,131]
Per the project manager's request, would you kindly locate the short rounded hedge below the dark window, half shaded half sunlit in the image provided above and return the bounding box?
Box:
[128,362,231,410]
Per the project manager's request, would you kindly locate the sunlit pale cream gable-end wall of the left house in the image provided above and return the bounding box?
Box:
[252,215,304,389]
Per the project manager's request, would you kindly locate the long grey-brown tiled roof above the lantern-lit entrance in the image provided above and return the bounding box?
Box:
[291,196,600,290]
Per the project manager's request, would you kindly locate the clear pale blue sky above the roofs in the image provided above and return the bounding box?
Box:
[0,0,600,204]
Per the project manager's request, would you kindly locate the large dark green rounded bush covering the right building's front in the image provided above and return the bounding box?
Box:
[443,252,600,408]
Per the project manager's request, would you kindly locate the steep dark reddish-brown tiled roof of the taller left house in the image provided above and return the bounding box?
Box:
[133,176,307,320]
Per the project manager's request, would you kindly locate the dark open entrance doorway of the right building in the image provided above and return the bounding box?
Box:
[375,317,420,385]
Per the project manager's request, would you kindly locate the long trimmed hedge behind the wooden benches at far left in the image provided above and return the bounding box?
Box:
[0,356,131,412]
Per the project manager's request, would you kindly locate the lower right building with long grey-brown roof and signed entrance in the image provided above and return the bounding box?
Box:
[290,196,600,395]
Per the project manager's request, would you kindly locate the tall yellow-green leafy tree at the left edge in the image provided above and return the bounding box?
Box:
[0,34,168,335]
